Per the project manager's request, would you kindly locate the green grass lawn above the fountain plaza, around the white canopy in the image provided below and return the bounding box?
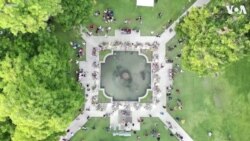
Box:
[87,0,195,35]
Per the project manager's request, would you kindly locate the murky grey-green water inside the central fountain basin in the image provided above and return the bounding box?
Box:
[101,51,151,101]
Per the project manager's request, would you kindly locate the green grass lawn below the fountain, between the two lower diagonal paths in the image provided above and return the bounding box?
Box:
[71,118,177,141]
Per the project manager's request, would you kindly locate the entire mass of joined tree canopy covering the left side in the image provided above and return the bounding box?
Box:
[0,0,92,141]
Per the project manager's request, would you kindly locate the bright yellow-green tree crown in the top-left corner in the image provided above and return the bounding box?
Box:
[0,0,62,34]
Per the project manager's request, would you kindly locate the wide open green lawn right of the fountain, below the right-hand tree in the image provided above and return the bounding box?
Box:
[166,35,250,141]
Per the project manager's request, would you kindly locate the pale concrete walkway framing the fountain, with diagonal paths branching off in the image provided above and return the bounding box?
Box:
[60,0,210,141]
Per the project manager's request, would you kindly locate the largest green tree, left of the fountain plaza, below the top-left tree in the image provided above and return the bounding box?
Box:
[0,31,83,141]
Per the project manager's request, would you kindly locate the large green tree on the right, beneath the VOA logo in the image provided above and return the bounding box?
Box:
[177,0,250,75]
